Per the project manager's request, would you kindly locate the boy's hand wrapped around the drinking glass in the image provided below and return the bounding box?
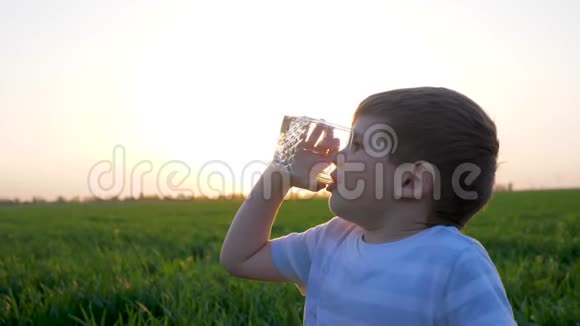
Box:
[286,125,340,191]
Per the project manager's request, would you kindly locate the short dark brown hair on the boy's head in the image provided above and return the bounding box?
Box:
[353,87,499,228]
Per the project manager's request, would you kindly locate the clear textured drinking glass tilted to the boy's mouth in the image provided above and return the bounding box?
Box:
[274,116,351,184]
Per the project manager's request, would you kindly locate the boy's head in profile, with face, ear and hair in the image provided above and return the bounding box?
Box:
[330,87,499,228]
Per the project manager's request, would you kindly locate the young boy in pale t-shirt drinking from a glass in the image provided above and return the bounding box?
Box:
[220,87,515,325]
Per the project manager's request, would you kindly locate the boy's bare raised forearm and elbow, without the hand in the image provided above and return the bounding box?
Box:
[220,165,290,281]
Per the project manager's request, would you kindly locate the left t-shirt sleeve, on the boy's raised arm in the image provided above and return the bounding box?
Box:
[270,221,330,295]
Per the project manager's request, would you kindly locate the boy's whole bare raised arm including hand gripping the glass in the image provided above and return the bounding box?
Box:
[220,126,338,281]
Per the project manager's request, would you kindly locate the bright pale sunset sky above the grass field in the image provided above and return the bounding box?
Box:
[0,0,580,199]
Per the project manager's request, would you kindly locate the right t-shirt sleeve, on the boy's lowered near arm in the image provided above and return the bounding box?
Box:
[444,243,517,326]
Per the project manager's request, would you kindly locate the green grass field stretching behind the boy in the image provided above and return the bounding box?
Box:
[0,190,580,325]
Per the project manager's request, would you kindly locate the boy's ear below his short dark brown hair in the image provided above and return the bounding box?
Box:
[399,161,435,199]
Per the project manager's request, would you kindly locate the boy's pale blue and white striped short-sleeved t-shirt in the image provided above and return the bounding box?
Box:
[272,217,516,326]
